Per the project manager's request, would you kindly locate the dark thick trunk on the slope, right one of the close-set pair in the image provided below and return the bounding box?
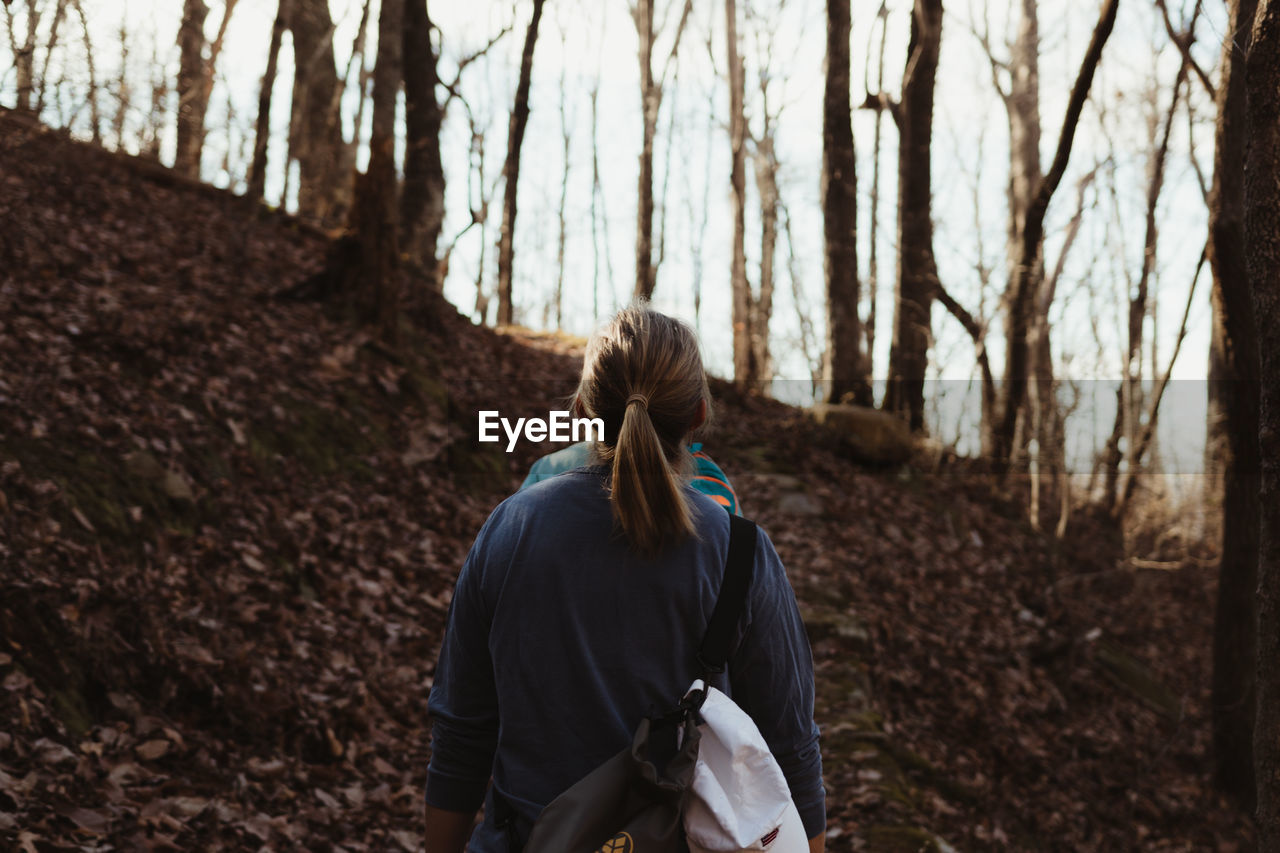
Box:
[401,0,444,292]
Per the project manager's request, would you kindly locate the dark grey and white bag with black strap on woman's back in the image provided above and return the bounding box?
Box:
[494,516,808,853]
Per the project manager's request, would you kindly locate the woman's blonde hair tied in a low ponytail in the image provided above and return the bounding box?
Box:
[575,304,710,556]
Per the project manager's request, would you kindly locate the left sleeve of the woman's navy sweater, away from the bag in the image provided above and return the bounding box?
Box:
[426,512,498,812]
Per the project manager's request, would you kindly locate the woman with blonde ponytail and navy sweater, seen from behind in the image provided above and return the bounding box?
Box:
[426,306,826,853]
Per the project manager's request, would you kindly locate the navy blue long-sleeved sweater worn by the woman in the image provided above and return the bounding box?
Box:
[426,467,826,853]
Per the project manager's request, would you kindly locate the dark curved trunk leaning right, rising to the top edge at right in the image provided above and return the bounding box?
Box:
[992,0,1119,474]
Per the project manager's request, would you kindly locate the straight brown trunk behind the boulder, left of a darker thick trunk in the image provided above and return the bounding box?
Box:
[819,0,872,406]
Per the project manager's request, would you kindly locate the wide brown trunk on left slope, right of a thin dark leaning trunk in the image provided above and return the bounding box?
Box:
[289,0,351,227]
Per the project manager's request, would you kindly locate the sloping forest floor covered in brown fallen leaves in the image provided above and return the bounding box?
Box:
[0,111,1253,852]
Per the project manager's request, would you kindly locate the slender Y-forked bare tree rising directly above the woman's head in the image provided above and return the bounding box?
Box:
[631,0,694,300]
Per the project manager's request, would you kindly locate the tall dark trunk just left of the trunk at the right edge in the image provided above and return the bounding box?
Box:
[1208,0,1258,811]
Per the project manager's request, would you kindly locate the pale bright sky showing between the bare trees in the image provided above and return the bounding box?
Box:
[0,0,1225,479]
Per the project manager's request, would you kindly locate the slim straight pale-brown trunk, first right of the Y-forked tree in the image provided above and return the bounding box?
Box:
[724,0,759,387]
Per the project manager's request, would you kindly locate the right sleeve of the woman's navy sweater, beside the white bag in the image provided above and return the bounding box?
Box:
[730,529,827,838]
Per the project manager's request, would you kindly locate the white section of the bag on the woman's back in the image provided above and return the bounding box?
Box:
[685,679,809,853]
